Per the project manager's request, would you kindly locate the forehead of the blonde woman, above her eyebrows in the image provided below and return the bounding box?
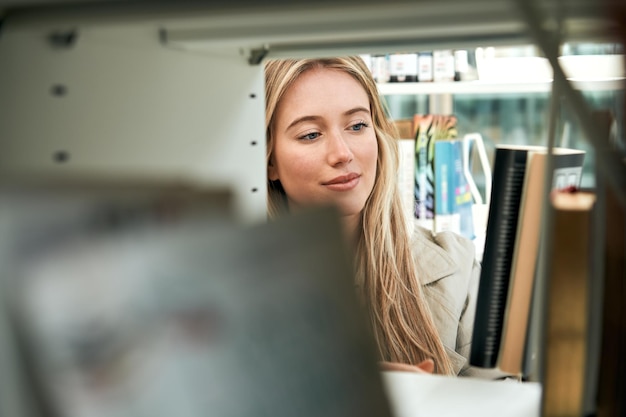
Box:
[277,68,370,123]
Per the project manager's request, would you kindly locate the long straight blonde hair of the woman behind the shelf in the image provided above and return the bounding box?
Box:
[265,57,454,374]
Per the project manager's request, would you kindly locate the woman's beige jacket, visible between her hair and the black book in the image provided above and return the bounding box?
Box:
[412,226,486,378]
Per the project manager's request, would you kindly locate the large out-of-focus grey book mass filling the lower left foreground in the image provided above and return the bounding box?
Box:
[1,181,389,417]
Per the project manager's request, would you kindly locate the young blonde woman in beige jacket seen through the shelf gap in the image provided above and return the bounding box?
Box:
[265,57,479,375]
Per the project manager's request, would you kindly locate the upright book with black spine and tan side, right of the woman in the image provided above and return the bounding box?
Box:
[470,145,585,376]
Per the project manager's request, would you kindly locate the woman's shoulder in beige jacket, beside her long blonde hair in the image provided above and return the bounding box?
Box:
[411,224,476,285]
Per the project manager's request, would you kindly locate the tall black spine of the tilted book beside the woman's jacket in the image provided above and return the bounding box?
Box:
[470,148,528,368]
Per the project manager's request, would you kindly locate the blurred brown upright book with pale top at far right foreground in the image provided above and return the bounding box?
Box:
[542,191,596,416]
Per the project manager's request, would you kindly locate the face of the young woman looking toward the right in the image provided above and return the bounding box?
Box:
[268,68,378,220]
